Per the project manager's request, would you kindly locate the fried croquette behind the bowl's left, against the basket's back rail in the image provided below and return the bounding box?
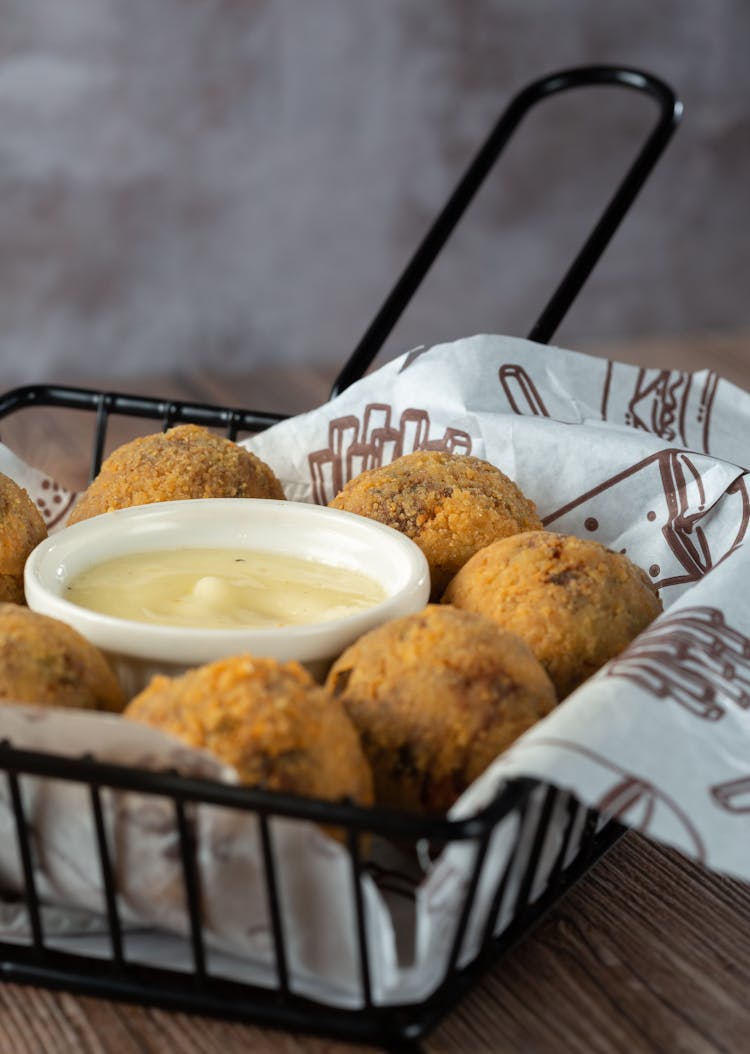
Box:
[68,425,284,524]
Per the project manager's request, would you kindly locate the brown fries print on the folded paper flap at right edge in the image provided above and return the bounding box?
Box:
[606,607,750,721]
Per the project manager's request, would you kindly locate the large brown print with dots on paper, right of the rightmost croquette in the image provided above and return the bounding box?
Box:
[542,450,750,588]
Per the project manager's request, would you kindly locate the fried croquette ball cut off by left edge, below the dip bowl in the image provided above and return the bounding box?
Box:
[0,604,125,711]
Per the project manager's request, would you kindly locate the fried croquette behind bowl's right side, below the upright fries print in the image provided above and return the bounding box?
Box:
[330,450,541,600]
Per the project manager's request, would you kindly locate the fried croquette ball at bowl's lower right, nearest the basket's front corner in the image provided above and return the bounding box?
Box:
[325,604,556,813]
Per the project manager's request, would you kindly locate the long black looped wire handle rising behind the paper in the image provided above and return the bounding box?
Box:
[330,65,683,398]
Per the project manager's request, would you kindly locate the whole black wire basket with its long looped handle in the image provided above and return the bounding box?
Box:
[0,66,682,1046]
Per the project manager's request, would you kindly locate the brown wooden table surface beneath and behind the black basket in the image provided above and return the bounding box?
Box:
[0,338,750,1054]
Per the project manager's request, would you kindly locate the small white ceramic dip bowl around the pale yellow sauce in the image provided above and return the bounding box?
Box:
[24,497,430,697]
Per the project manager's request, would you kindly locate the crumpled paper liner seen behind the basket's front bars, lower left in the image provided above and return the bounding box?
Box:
[0,705,395,1006]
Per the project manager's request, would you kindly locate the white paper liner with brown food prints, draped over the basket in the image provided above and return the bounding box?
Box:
[0,336,750,1006]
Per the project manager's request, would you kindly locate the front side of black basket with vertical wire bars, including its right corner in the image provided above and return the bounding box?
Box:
[0,742,621,1043]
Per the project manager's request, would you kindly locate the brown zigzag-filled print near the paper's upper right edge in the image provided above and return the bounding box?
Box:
[601,363,718,453]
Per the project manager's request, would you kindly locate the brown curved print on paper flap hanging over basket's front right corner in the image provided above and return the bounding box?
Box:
[518,736,707,863]
